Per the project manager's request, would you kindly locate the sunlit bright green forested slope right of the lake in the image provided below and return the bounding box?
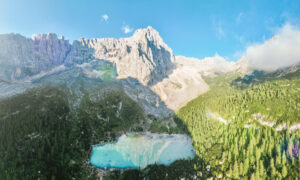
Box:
[178,72,300,179]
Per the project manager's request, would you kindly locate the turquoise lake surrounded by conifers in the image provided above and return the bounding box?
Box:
[90,133,195,169]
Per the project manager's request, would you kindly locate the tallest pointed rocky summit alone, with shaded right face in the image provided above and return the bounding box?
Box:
[122,26,175,85]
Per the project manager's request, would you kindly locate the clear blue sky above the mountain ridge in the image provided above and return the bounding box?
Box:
[0,0,300,61]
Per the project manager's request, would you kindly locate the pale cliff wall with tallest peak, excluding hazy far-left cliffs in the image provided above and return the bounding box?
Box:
[68,27,174,86]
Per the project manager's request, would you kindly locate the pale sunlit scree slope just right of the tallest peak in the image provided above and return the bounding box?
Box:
[151,56,237,111]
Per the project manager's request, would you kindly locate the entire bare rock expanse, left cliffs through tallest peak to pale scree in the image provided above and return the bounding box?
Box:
[0,27,234,116]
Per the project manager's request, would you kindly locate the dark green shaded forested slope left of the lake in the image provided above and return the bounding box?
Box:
[0,86,144,179]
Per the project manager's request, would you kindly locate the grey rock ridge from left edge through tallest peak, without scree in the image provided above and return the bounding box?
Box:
[0,26,175,85]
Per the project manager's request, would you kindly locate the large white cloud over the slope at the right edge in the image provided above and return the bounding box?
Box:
[245,24,300,71]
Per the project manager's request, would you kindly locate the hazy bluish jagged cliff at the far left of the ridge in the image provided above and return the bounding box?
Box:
[0,34,71,81]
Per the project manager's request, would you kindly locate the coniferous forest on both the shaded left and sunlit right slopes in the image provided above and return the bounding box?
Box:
[0,69,300,179]
